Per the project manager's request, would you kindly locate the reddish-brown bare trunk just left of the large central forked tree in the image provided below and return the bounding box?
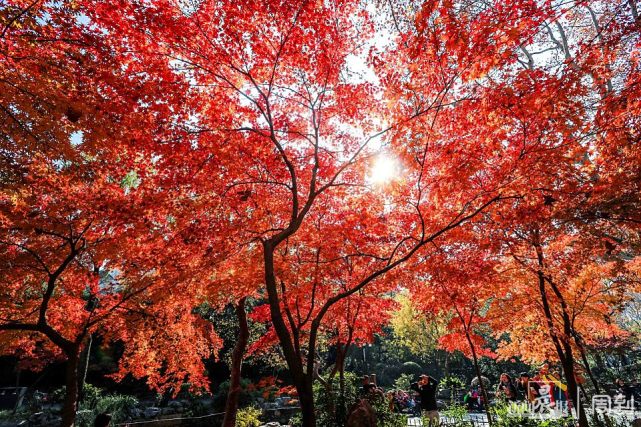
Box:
[223,298,249,427]
